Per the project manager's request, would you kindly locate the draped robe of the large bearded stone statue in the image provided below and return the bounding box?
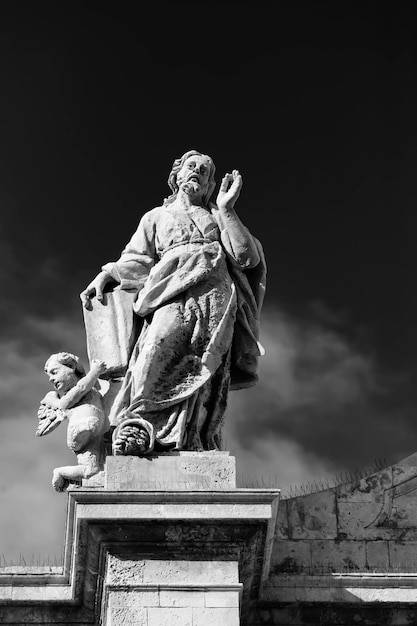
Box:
[103,204,265,450]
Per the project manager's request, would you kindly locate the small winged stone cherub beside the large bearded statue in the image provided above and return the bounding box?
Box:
[36,352,110,491]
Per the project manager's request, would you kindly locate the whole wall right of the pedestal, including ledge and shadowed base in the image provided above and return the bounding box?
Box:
[248,455,417,626]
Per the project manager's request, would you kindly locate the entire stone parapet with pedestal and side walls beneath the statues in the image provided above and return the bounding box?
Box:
[4,454,417,626]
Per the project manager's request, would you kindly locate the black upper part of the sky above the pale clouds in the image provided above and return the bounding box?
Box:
[0,2,417,356]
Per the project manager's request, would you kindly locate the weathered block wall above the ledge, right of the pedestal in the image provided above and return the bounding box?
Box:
[272,456,417,574]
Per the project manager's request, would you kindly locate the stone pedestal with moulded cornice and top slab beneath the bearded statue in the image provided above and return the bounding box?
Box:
[77,452,278,626]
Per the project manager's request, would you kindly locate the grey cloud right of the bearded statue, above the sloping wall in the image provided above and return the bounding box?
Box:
[226,308,417,488]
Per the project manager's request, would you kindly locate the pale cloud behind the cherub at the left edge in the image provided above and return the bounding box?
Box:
[0,316,86,563]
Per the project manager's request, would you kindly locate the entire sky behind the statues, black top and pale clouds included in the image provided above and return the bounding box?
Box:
[0,1,417,565]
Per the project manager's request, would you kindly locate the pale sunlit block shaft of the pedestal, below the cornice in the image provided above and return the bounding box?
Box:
[103,555,242,626]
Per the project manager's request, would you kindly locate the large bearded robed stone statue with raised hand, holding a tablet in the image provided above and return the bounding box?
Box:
[81,150,266,455]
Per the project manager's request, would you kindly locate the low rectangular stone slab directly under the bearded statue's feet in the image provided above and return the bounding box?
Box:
[106,452,236,491]
